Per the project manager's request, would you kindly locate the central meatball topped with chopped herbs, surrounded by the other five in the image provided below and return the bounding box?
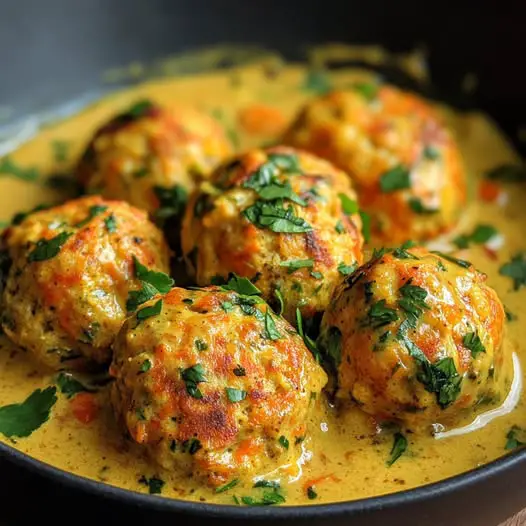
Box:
[181,147,363,321]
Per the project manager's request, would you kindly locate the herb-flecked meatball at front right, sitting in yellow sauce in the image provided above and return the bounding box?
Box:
[319,246,509,428]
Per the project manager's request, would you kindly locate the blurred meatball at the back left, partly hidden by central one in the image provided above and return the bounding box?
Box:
[77,101,230,216]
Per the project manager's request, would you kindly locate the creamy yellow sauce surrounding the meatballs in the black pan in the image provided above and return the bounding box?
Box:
[0,53,526,504]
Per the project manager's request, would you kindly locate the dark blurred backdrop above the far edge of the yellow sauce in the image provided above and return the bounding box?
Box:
[0,0,526,155]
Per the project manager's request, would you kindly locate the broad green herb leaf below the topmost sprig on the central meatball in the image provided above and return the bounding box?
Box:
[243,200,312,234]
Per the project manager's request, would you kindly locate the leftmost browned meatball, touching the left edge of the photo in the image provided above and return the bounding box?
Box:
[1,196,171,369]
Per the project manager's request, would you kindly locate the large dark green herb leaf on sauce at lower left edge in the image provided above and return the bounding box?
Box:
[0,386,57,438]
